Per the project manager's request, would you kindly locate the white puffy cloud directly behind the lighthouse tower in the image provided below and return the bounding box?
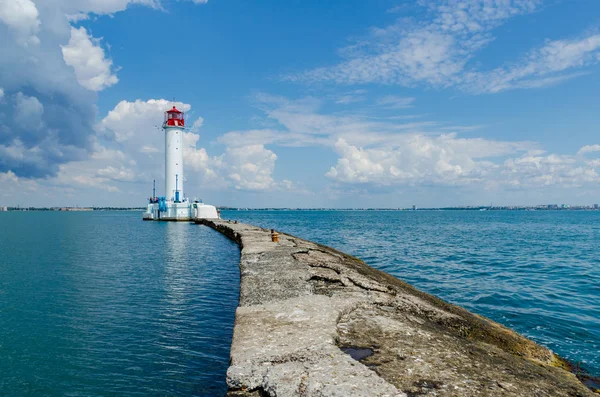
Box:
[92,99,288,191]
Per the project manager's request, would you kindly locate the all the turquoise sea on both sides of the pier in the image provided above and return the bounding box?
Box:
[0,211,600,396]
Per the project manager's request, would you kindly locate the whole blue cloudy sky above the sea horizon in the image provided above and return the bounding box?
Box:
[0,0,600,208]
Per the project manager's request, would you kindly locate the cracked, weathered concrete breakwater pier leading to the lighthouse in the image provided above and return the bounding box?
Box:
[196,219,598,397]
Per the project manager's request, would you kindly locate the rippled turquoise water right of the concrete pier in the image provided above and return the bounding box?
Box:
[223,211,600,375]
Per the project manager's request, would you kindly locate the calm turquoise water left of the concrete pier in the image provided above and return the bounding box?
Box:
[0,212,239,396]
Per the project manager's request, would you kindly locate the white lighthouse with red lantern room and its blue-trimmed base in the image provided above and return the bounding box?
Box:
[143,106,219,221]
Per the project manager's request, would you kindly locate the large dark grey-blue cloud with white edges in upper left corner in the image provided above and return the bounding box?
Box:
[0,0,213,187]
